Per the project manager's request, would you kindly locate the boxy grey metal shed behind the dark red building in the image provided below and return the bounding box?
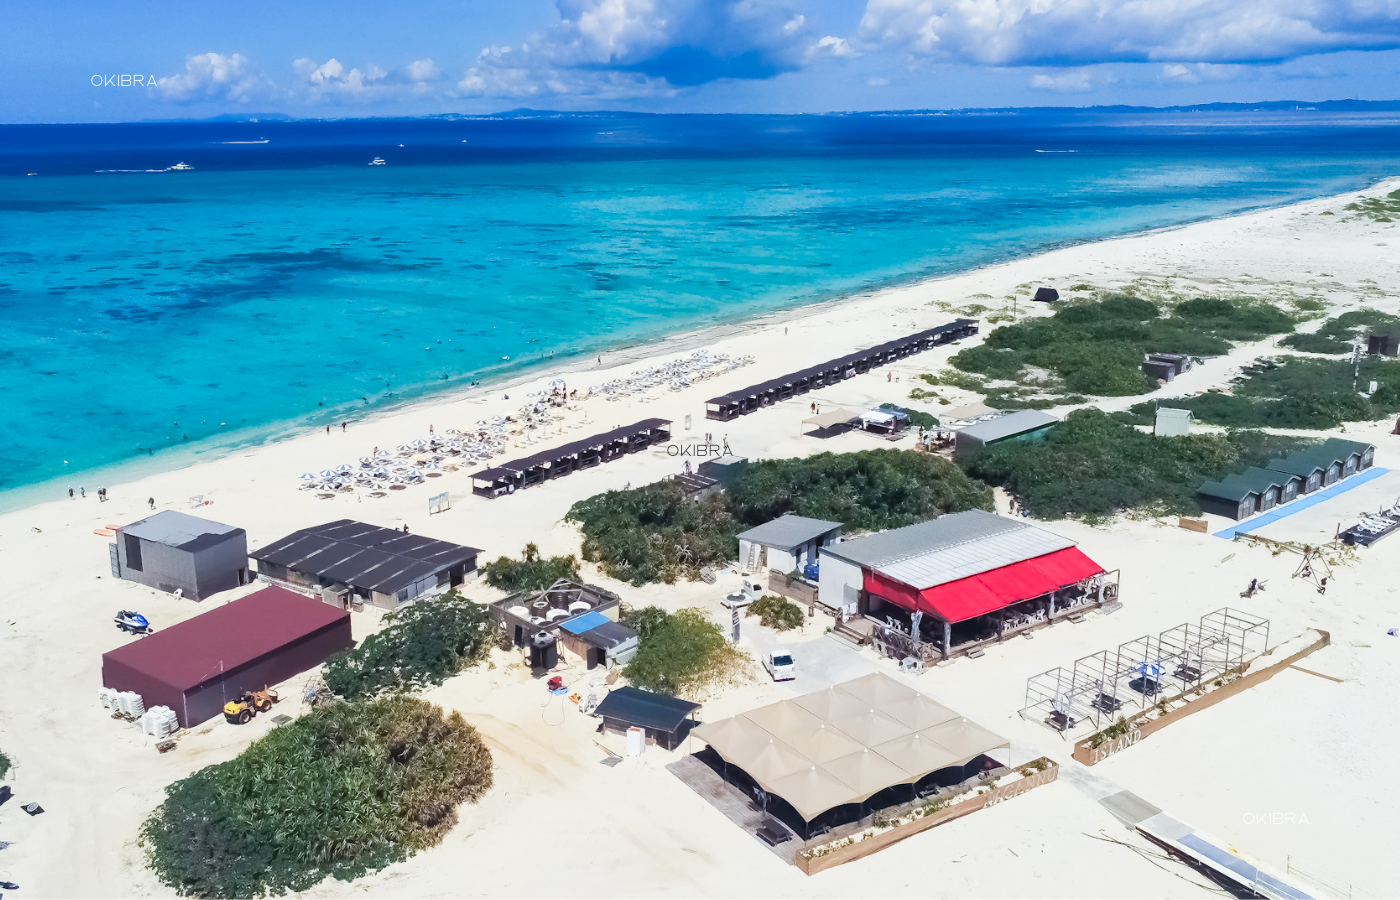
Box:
[108,509,248,600]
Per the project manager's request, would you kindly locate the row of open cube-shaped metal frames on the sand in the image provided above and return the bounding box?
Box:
[1021,606,1268,738]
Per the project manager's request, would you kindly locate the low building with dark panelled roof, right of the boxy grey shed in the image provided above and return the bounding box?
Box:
[249,519,480,607]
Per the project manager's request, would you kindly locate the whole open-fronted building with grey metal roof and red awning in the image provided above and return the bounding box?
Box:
[820,509,1117,661]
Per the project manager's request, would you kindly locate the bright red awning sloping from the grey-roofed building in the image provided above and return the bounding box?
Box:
[865,547,1103,621]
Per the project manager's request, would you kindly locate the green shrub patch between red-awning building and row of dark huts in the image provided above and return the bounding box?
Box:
[963,409,1306,521]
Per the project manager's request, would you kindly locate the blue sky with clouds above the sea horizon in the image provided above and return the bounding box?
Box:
[8,0,1400,122]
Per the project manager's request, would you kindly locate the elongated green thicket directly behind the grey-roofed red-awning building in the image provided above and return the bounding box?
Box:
[568,449,991,586]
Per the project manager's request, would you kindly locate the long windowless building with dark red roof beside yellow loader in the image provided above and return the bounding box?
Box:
[102,588,354,728]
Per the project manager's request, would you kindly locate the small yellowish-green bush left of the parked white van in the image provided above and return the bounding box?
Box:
[622,606,752,698]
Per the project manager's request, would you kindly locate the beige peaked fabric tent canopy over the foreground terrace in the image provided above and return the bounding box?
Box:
[690,672,1007,822]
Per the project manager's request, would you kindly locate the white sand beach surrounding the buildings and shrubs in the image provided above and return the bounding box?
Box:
[0,179,1400,897]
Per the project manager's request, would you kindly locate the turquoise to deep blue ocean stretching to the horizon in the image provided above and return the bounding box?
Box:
[0,111,1400,507]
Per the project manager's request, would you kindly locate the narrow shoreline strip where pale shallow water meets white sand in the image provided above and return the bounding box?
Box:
[0,175,1400,515]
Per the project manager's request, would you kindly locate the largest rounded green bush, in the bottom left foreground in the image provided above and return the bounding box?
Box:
[141,696,493,897]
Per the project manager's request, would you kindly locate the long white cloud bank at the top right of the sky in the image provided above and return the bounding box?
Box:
[860,0,1400,66]
